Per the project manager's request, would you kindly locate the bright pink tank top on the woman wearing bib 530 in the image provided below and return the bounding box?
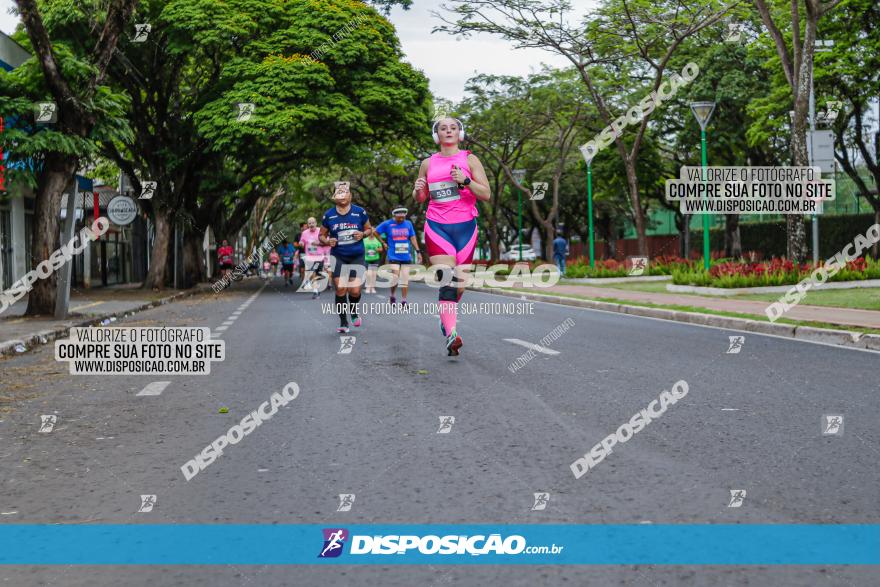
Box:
[425,151,479,224]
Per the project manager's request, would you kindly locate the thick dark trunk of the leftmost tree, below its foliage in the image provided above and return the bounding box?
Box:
[25,152,77,316]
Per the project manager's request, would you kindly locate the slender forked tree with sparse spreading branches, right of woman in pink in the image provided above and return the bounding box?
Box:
[439,0,737,255]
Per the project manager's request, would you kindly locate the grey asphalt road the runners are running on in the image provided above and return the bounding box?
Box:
[0,279,880,586]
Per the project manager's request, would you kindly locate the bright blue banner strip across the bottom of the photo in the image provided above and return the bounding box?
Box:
[0,524,880,566]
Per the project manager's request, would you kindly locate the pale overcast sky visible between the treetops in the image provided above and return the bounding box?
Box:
[0,0,596,101]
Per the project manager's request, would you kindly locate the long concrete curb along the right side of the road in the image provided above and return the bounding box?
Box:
[467,287,880,351]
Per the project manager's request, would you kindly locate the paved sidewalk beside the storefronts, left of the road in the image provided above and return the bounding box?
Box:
[0,284,211,356]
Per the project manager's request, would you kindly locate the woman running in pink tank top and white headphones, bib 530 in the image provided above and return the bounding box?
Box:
[413,118,492,356]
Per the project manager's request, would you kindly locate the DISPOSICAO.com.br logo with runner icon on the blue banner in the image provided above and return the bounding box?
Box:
[318,528,565,558]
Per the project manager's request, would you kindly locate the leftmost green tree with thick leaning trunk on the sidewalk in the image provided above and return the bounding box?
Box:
[6,0,137,315]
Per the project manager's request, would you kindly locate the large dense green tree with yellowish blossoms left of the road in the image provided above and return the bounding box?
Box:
[101,0,427,287]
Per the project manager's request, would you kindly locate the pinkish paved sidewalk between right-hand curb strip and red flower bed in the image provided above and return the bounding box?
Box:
[507,284,880,329]
